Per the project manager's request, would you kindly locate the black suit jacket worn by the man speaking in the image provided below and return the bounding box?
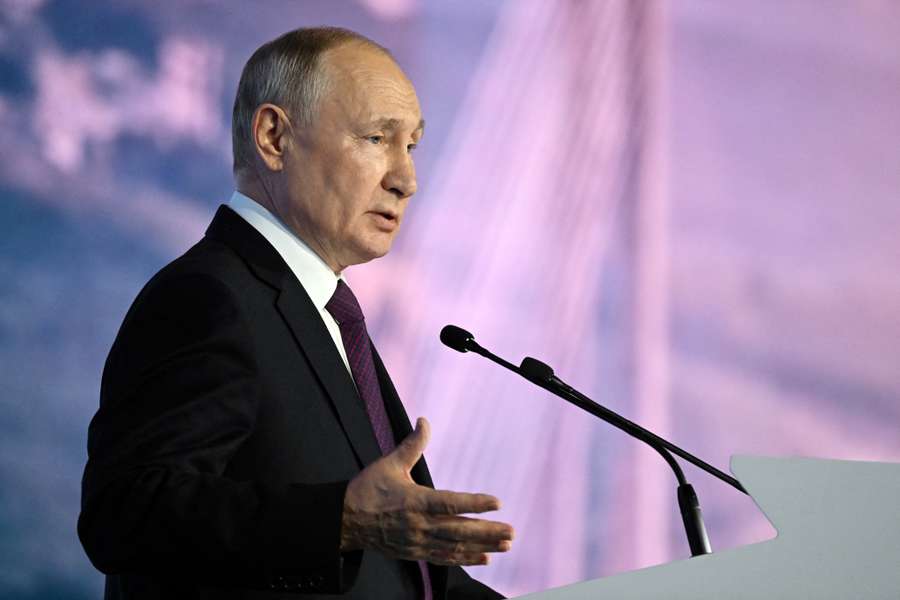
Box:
[78,207,500,600]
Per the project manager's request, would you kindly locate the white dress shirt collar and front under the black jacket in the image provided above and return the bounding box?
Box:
[228,191,352,377]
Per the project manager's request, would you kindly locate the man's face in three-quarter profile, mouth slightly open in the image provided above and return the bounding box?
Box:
[274,44,423,272]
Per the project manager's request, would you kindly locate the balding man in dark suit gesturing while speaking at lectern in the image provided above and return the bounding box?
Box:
[78,28,512,599]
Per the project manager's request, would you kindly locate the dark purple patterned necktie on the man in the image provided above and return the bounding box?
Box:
[325,279,431,600]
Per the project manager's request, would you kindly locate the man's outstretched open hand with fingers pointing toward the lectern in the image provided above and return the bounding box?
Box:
[341,418,513,565]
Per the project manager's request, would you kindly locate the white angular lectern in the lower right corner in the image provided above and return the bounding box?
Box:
[522,456,900,600]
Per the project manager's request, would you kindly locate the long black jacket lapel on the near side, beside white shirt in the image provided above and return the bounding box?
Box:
[207,206,382,466]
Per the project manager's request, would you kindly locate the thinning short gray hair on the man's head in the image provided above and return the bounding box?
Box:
[231,27,391,172]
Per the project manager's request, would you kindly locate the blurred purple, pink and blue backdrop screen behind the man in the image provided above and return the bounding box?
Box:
[0,0,900,600]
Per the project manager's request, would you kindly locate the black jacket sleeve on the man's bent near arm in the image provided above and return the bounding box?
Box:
[78,274,360,593]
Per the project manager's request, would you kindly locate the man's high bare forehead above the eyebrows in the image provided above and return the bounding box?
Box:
[322,43,422,129]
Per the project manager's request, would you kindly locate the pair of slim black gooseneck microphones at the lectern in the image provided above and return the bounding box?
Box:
[441,325,747,556]
